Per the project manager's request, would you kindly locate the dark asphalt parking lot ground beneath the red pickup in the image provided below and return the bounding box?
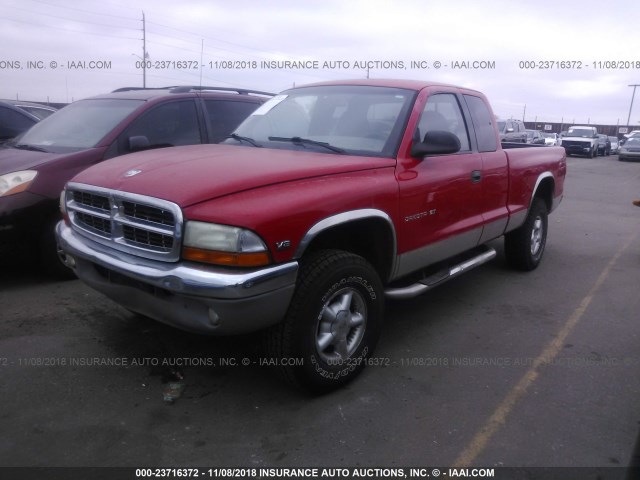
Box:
[0,156,640,478]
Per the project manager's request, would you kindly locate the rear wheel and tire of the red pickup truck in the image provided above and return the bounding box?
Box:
[504,198,548,271]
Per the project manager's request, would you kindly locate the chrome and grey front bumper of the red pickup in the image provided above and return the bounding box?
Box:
[56,222,298,335]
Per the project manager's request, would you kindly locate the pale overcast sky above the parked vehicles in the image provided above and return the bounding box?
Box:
[0,0,640,127]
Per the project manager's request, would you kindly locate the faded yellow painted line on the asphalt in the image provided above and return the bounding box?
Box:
[453,232,638,468]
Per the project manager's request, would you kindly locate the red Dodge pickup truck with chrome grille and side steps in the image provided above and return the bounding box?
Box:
[57,80,566,391]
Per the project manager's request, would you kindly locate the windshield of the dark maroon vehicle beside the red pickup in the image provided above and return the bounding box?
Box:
[16,98,143,153]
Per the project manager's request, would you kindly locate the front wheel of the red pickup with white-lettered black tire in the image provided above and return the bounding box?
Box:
[266,250,384,393]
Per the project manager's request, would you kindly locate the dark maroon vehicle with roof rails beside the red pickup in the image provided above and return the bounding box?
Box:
[0,87,271,277]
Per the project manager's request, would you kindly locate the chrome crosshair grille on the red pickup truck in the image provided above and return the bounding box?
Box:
[65,183,183,262]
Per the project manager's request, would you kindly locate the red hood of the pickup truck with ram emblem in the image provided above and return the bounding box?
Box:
[72,144,396,208]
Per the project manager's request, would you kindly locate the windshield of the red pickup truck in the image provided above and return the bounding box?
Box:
[225,85,416,156]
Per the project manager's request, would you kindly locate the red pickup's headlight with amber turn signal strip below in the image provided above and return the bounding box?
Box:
[182,221,271,267]
